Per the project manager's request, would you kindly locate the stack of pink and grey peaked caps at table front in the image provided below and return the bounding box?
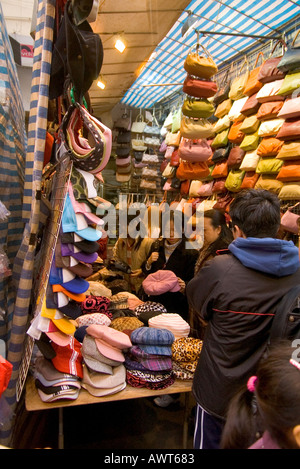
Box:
[82,324,132,397]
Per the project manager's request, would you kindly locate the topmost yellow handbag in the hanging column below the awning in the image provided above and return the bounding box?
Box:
[183,42,218,79]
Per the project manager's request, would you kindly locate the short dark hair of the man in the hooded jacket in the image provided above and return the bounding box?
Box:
[229,189,280,238]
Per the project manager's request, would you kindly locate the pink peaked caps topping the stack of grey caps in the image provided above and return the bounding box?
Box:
[86,324,132,362]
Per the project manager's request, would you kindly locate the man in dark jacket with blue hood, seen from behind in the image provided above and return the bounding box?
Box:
[186,189,300,449]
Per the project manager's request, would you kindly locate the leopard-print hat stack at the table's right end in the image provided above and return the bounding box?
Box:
[172,337,203,379]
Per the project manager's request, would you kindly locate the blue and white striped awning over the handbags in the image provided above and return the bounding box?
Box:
[121,0,300,109]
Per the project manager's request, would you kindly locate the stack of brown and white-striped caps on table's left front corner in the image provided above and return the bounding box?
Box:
[34,357,81,402]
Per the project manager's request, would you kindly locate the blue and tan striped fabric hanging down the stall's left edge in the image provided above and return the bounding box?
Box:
[0,0,55,446]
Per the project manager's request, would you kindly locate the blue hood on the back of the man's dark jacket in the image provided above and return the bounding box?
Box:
[228,238,300,277]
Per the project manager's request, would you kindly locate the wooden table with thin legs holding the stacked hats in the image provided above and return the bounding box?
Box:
[25,376,192,449]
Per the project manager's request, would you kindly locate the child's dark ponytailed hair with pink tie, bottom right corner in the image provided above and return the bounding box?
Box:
[221,341,300,449]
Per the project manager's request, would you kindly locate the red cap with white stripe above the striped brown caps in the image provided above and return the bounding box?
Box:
[52,337,83,378]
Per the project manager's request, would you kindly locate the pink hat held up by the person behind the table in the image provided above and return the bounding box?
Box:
[143,270,180,295]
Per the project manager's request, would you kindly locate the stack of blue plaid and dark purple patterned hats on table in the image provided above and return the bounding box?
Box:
[125,326,175,389]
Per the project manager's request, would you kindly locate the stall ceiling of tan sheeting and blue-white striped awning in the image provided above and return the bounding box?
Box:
[90,0,300,114]
